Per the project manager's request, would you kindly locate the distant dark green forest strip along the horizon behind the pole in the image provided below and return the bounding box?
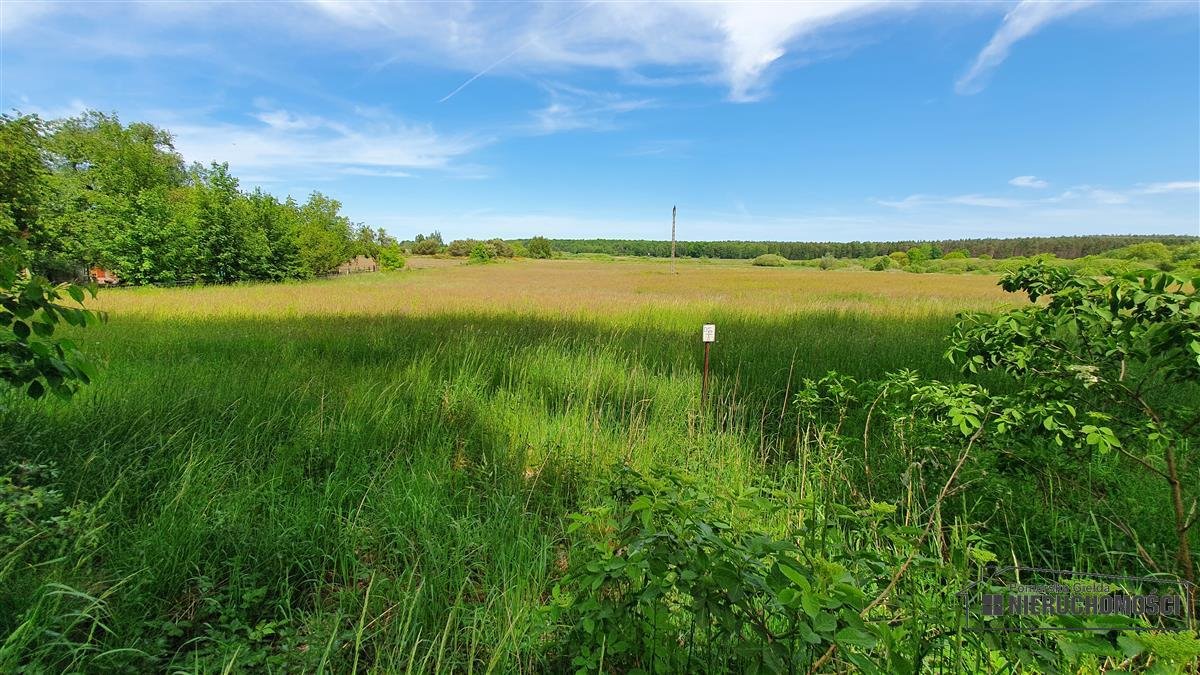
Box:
[551,234,1200,261]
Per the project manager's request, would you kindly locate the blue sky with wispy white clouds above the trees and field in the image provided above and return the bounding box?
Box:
[0,0,1200,240]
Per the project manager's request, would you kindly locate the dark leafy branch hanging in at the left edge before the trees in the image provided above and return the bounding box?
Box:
[0,234,102,399]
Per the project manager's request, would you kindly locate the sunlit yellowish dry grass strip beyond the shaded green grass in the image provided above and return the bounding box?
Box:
[95,258,1015,317]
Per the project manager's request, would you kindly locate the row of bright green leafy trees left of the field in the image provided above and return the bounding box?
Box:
[0,112,403,283]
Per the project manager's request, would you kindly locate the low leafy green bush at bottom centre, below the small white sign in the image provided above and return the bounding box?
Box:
[550,467,888,673]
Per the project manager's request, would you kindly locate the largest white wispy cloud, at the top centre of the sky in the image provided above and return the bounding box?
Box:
[313,0,914,101]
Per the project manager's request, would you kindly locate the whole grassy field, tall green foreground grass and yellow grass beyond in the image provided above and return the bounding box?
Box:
[0,259,1180,671]
